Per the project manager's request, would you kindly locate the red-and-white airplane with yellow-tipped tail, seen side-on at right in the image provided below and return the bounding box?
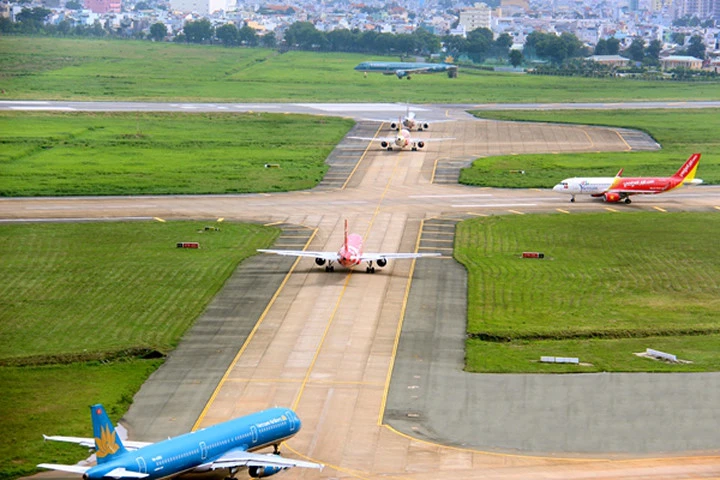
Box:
[553,153,702,204]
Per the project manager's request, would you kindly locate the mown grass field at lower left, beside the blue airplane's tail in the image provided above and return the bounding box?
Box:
[0,222,279,478]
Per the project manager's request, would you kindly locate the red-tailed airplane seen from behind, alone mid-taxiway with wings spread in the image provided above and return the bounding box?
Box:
[258,220,440,273]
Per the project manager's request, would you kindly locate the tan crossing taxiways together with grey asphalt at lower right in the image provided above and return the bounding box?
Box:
[9,105,720,479]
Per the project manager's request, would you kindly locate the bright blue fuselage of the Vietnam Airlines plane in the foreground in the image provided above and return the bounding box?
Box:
[84,408,301,480]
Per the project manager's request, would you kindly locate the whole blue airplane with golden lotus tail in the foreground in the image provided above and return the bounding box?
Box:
[38,404,323,480]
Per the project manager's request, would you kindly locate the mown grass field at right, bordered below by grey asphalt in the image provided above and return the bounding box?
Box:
[455,213,720,372]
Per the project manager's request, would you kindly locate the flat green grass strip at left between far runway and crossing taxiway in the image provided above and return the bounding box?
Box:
[0,112,353,196]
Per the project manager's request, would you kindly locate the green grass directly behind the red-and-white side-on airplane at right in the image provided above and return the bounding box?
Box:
[460,109,720,188]
